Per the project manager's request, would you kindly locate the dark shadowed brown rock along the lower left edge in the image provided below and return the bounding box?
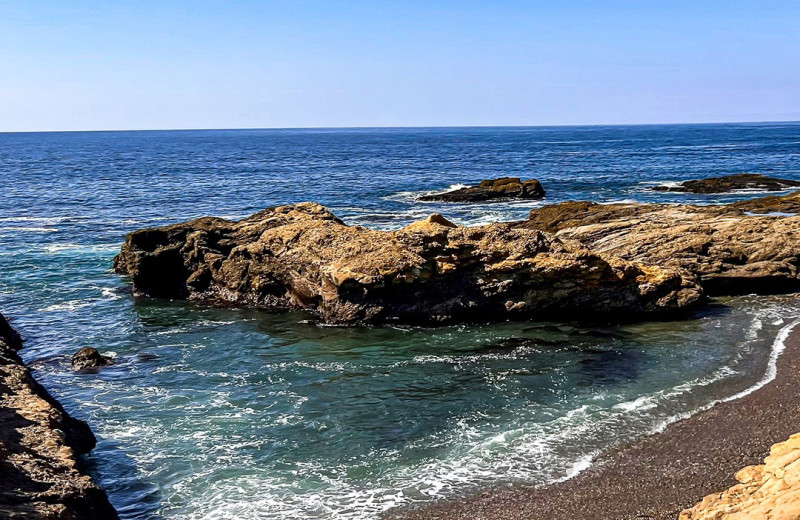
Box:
[0,315,117,520]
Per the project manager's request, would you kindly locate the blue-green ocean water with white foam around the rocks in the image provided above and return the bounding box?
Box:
[0,123,800,519]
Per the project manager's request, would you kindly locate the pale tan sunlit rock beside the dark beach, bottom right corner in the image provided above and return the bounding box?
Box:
[679,433,800,520]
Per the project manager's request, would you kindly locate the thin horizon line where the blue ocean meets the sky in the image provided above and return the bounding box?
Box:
[0,119,800,134]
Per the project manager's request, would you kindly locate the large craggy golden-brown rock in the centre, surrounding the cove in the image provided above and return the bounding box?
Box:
[115,203,702,324]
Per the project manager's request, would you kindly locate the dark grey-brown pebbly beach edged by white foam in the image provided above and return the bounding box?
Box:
[390,319,800,520]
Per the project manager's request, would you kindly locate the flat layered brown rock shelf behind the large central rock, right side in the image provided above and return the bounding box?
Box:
[519,193,800,294]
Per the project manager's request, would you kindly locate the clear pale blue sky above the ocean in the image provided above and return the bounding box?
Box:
[0,0,800,131]
